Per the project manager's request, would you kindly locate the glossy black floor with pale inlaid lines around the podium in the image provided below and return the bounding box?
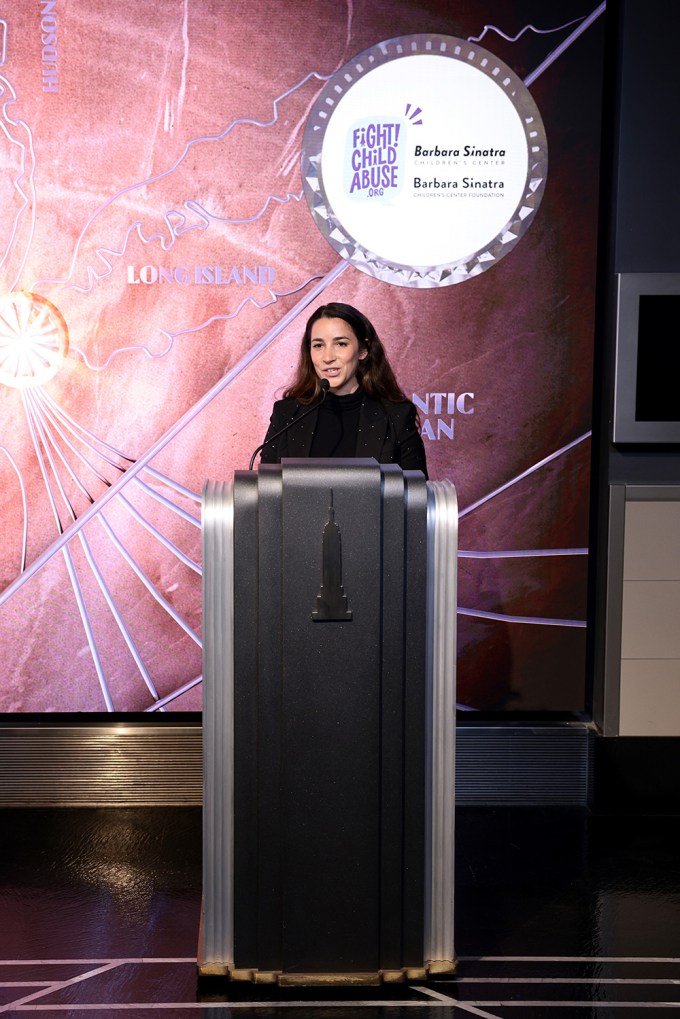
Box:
[0,807,680,1019]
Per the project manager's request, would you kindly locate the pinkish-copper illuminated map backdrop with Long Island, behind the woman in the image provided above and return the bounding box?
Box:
[0,0,604,712]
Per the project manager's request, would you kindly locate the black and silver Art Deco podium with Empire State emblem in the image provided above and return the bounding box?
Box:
[198,460,458,986]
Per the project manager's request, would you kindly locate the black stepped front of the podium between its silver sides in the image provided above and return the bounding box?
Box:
[233,460,427,974]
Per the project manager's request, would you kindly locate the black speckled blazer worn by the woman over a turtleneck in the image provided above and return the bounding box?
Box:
[260,396,427,477]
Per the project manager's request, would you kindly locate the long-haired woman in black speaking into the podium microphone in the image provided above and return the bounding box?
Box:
[260,303,427,477]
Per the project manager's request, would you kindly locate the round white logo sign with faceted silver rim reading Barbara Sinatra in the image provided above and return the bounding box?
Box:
[302,35,547,287]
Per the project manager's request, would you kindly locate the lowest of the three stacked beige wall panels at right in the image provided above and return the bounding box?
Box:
[620,659,680,736]
